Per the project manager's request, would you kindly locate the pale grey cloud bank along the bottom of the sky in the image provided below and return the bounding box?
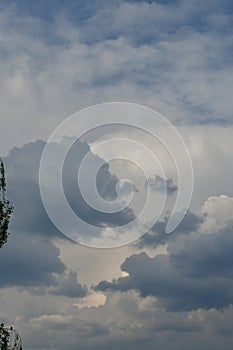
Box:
[9,292,233,350]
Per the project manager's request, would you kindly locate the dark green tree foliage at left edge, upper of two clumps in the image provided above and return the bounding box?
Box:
[0,159,13,248]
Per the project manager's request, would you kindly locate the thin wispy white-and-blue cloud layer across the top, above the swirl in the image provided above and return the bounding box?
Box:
[0,1,233,156]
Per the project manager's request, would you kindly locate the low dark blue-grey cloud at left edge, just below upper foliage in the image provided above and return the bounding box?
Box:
[0,233,65,287]
